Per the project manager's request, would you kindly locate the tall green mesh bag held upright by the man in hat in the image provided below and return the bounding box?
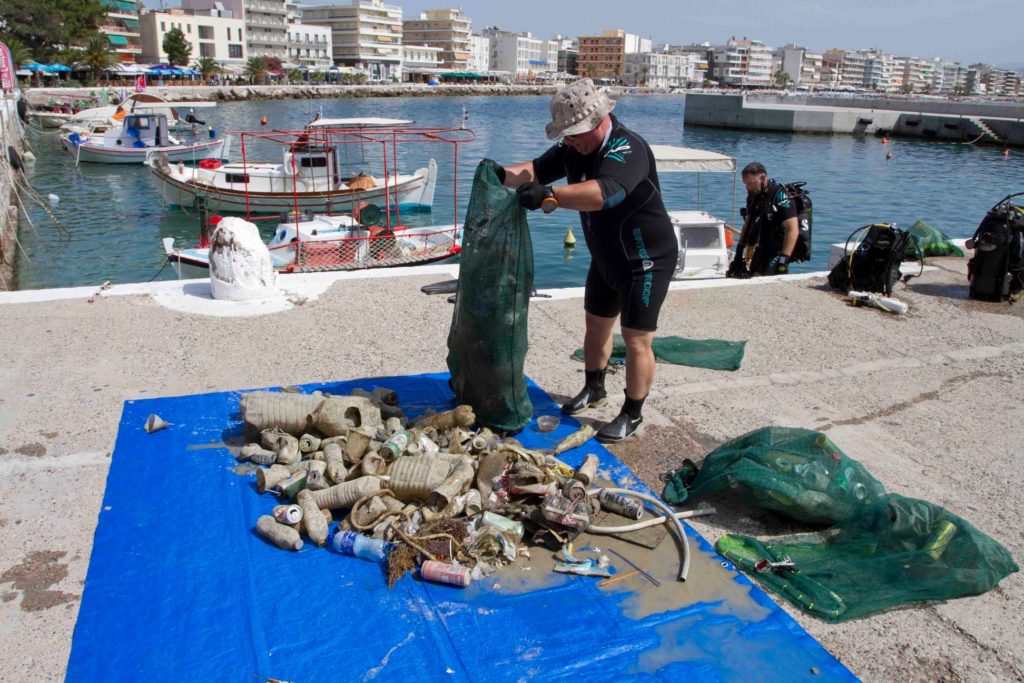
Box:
[447,160,534,432]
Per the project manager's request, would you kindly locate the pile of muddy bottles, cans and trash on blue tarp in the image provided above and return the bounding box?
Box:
[238,388,688,586]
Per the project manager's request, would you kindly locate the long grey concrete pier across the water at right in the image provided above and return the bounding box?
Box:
[685,93,1024,146]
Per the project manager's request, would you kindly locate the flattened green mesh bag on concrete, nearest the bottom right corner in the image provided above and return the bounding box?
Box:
[715,494,1019,623]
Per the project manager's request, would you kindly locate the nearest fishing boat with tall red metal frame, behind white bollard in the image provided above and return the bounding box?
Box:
[160,120,476,278]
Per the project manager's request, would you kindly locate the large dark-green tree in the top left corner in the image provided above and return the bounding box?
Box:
[0,0,106,59]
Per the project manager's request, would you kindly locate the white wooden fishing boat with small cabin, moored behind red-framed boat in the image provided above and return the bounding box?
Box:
[147,119,437,214]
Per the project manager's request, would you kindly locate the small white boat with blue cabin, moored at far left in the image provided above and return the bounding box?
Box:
[60,114,226,164]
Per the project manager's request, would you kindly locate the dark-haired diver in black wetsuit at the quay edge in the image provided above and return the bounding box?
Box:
[726,162,800,278]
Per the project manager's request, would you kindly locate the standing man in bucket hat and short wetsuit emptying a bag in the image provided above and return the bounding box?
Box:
[489,79,678,443]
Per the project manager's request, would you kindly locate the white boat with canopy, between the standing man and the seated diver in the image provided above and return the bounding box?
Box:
[651,144,739,280]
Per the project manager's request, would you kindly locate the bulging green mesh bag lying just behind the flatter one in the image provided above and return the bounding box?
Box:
[663,427,886,524]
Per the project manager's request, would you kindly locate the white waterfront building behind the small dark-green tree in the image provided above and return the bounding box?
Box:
[139,7,248,68]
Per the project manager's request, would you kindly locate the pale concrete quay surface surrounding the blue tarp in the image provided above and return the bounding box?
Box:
[0,259,1024,681]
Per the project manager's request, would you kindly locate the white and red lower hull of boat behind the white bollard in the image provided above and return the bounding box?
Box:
[163,214,462,279]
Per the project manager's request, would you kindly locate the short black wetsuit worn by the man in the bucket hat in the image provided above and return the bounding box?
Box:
[534,116,679,331]
